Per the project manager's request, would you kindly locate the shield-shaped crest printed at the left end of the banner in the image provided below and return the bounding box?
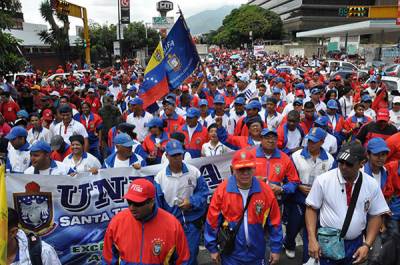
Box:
[13,182,56,236]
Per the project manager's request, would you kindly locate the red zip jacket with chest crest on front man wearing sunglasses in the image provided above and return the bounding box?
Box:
[102,208,190,265]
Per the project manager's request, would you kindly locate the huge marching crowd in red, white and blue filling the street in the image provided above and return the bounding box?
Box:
[0,49,400,264]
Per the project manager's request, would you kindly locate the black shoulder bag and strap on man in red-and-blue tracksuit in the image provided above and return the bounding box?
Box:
[217,194,253,256]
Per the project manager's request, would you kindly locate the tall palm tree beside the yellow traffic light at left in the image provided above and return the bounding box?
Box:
[38,0,70,61]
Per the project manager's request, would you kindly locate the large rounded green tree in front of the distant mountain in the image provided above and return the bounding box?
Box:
[210,5,282,48]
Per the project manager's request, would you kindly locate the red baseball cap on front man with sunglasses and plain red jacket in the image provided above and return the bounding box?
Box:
[124,178,156,203]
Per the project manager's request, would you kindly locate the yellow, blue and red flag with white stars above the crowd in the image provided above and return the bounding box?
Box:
[139,42,169,109]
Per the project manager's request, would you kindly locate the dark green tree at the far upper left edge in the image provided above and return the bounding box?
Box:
[0,0,25,75]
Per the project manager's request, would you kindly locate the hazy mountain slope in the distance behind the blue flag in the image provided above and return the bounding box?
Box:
[186,5,238,35]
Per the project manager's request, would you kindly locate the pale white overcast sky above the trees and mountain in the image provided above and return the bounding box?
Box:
[20,0,247,35]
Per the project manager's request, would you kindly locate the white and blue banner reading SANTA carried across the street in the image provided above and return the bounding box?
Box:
[6,153,233,264]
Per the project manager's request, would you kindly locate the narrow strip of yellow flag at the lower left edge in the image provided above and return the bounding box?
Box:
[0,165,8,265]
